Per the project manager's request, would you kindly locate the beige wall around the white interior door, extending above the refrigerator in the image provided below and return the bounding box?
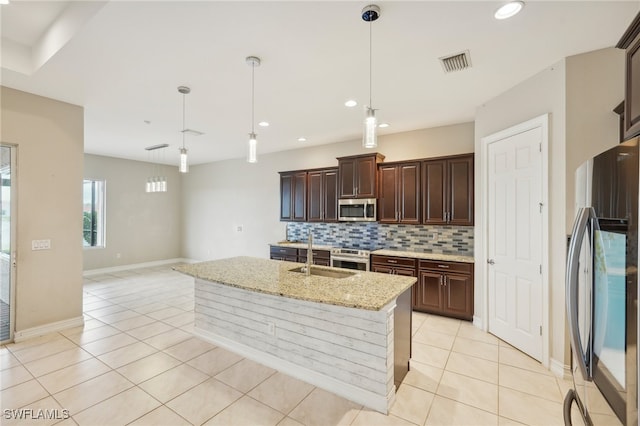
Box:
[475,48,624,367]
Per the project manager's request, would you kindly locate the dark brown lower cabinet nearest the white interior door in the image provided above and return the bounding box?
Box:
[413,260,473,320]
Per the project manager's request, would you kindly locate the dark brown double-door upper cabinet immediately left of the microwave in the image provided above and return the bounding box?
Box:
[307,169,338,222]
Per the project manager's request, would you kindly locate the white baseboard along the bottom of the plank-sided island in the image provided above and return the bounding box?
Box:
[193,328,395,414]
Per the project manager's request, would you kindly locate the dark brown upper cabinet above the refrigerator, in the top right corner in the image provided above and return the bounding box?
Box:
[616,13,640,140]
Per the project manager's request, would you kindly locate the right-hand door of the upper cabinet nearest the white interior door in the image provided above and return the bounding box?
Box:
[447,155,473,225]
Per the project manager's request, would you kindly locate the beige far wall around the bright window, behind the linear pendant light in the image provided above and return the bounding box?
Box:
[83,154,181,271]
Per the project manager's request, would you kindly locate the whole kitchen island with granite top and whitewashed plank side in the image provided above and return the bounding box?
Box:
[175,257,416,414]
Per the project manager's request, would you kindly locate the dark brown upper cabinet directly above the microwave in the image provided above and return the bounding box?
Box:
[338,153,384,198]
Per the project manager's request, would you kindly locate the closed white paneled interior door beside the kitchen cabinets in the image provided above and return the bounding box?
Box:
[487,127,543,361]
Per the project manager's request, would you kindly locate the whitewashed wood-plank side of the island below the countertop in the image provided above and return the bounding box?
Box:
[195,279,395,413]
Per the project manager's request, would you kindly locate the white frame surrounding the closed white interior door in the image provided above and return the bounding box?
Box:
[476,114,551,368]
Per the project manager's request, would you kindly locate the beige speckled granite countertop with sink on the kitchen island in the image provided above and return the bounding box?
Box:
[174,257,417,311]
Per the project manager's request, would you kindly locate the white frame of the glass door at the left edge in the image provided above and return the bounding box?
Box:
[0,142,18,344]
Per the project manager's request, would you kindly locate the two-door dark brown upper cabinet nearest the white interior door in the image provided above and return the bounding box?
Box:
[422,154,473,225]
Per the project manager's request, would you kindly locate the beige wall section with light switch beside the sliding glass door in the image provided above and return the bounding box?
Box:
[0,87,84,332]
